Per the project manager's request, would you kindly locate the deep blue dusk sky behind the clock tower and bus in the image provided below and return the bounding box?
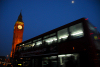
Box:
[0,0,100,56]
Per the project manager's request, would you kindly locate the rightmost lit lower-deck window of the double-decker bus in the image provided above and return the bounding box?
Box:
[58,54,80,67]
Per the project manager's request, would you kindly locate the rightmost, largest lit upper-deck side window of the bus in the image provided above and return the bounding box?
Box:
[69,23,84,38]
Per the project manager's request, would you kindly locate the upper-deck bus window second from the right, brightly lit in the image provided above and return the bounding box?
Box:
[58,28,69,42]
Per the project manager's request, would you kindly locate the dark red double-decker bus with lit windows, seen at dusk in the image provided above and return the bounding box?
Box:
[14,18,100,67]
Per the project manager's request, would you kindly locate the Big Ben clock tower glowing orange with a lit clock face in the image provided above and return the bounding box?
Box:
[10,12,24,57]
